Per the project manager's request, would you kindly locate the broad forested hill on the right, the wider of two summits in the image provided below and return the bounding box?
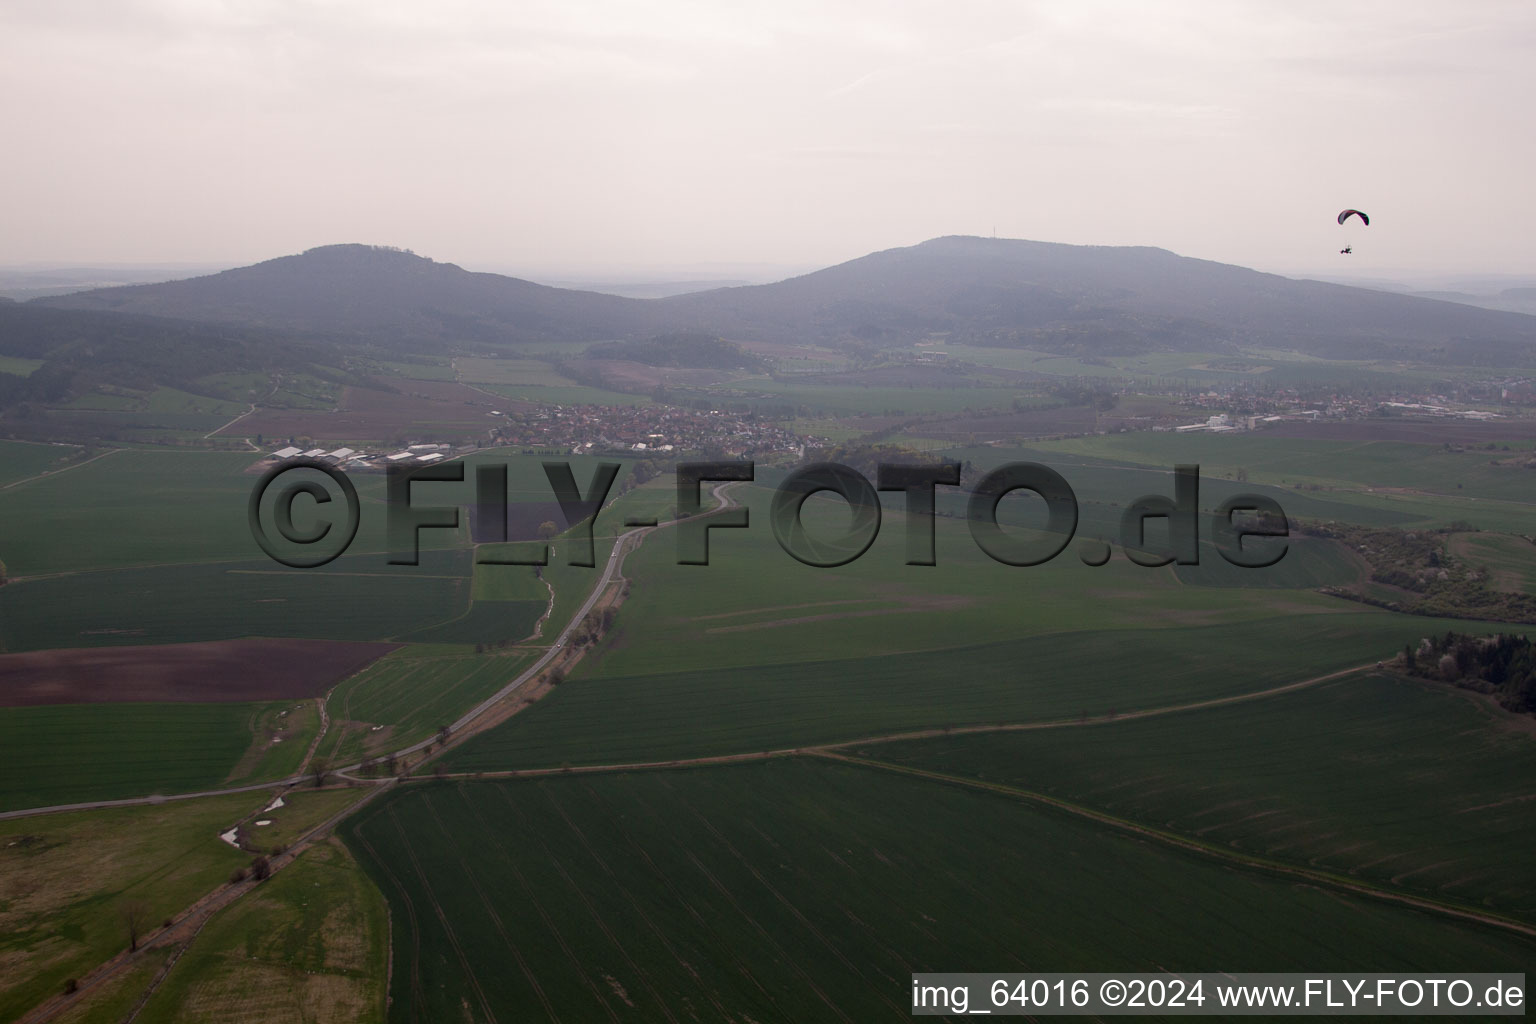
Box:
[660,236,1536,365]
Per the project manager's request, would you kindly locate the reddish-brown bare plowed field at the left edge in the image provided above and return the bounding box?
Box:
[0,639,398,708]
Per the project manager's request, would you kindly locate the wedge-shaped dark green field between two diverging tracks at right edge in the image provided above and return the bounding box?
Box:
[859,672,1536,921]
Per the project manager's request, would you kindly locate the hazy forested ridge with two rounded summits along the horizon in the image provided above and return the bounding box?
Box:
[29,236,1536,365]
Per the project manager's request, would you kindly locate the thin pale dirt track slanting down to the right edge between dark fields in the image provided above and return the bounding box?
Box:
[806,749,1536,938]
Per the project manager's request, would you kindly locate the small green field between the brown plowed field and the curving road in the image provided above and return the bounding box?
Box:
[318,646,535,765]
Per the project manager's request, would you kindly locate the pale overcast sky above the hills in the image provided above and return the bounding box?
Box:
[0,0,1536,275]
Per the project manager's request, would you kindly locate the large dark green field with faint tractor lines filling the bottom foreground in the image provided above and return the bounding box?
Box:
[344,760,1536,1021]
